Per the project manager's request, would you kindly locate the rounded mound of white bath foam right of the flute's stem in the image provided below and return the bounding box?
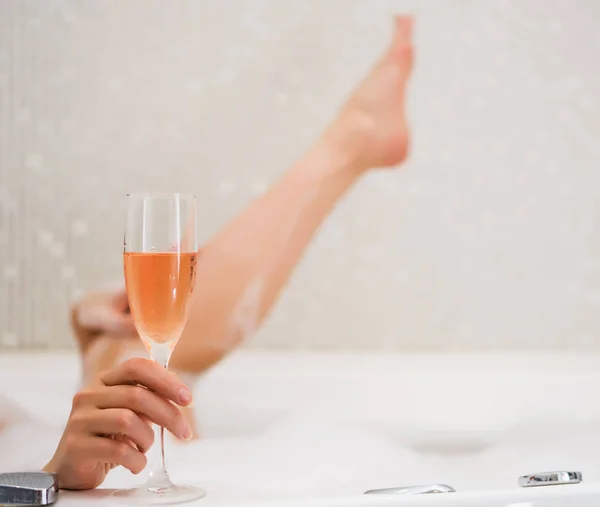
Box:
[199,414,423,494]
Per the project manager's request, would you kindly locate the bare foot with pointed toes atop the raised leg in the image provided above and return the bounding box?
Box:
[329,16,413,170]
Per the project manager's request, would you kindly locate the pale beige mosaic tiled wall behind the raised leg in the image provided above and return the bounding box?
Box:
[0,0,600,350]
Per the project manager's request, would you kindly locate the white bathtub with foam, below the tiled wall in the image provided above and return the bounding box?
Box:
[0,352,600,507]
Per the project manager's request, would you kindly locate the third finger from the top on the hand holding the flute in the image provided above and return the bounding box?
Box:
[86,408,154,453]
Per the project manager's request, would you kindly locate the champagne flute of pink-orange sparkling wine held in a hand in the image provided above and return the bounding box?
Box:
[114,193,205,505]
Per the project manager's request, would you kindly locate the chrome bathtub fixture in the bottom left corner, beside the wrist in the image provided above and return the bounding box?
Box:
[0,472,58,506]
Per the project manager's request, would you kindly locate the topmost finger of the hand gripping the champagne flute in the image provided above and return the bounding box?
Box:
[100,358,192,406]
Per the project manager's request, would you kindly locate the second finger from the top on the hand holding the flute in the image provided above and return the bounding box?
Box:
[92,386,192,440]
